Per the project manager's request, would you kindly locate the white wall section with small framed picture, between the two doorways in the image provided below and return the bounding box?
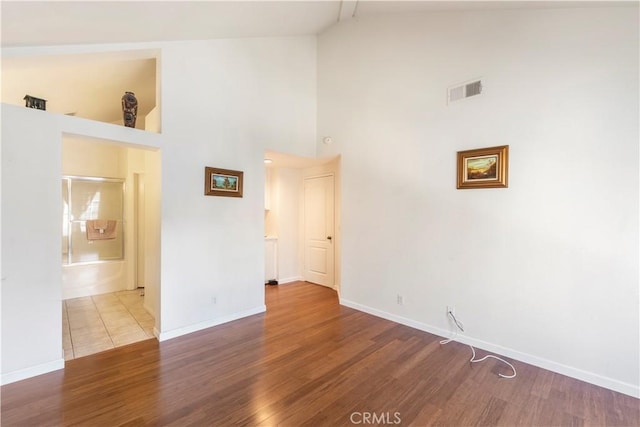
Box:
[153,37,316,339]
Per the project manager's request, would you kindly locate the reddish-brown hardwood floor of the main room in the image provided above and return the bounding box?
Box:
[1,282,640,426]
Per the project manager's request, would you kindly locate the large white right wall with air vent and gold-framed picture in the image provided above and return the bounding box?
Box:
[318,5,640,396]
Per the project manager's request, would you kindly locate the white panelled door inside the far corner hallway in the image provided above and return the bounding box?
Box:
[304,176,334,288]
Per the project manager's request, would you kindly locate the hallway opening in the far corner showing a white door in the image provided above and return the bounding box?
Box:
[264,151,341,292]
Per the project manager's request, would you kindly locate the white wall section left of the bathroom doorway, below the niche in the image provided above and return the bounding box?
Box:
[2,104,64,383]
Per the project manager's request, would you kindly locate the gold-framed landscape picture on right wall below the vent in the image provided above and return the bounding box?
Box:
[458,145,509,189]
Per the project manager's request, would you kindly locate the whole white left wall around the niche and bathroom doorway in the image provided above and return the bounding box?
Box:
[2,37,316,383]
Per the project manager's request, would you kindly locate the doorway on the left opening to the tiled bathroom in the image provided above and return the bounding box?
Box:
[62,135,161,360]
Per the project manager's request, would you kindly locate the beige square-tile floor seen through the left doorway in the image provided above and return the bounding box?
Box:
[62,290,155,360]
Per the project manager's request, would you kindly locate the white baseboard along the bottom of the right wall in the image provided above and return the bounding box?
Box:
[340,299,640,398]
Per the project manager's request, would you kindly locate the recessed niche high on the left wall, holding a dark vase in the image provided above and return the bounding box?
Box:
[2,50,160,133]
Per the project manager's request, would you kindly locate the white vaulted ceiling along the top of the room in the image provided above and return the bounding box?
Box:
[1,0,613,47]
